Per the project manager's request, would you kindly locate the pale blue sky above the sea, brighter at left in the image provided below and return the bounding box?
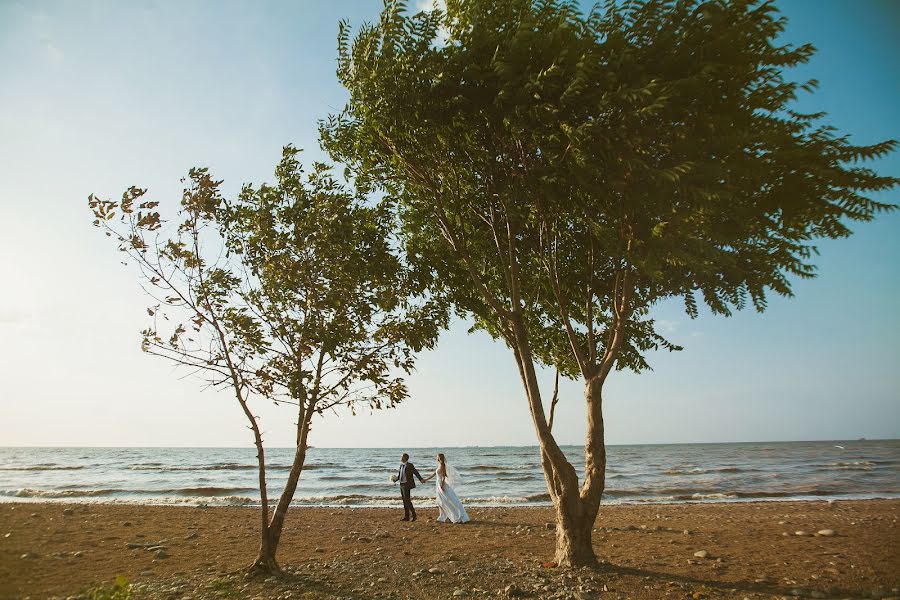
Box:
[0,0,900,447]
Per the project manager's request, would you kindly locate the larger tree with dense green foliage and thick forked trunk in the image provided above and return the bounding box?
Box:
[320,0,898,566]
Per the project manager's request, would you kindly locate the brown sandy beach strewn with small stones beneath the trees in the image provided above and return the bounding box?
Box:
[0,500,900,600]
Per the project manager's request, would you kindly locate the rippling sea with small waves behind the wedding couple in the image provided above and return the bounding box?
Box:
[0,440,900,506]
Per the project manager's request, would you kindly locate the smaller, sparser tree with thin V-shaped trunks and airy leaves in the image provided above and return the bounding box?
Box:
[90,147,446,573]
